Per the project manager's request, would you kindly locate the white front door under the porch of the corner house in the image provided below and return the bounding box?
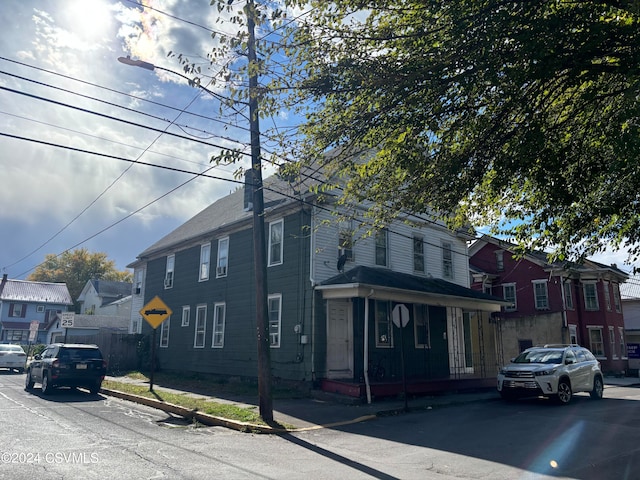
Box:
[327,299,353,379]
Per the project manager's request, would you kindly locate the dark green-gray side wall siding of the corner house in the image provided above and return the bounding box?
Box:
[145,211,312,380]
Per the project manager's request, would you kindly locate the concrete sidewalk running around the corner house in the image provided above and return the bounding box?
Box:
[102,377,640,433]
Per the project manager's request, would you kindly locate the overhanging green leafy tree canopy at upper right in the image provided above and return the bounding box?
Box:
[272,0,640,258]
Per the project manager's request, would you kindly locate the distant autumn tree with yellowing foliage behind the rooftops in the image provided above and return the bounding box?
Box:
[27,248,132,312]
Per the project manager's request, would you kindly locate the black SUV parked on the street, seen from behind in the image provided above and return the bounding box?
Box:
[24,343,107,395]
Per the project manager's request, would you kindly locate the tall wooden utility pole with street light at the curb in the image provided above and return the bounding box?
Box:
[245,0,273,423]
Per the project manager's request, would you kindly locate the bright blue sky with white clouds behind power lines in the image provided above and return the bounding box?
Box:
[0,0,631,279]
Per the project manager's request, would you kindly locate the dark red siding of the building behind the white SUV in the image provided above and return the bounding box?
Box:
[471,237,627,373]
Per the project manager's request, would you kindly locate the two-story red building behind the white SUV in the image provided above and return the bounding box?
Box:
[469,236,628,374]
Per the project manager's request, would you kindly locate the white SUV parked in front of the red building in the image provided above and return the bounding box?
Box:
[498,345,604,404]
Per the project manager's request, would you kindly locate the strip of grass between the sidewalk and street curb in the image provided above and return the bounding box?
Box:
[102,378,266,425]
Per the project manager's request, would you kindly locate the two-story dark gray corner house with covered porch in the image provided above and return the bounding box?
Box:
[129,171,504,396]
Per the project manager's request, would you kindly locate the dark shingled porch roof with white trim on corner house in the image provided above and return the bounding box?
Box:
[316,266,510,312]
